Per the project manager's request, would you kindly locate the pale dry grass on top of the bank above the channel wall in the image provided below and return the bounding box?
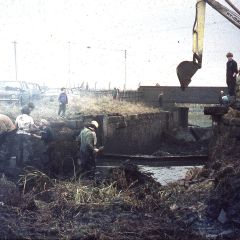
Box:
[0,96,159,120]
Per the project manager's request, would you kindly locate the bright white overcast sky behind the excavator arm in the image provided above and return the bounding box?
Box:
[0,0,240,89]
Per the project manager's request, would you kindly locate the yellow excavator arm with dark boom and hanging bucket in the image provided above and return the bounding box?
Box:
[177,0,240,91]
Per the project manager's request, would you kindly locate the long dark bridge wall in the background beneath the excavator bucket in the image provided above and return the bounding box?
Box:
[139,86,227,106]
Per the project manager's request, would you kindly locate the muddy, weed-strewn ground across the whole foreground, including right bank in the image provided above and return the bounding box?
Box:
[0,109,240,240]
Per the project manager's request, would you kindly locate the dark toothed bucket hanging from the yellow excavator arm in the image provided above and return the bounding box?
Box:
[177,61,199,91]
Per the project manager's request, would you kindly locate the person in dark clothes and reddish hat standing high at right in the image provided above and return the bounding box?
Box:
[226,52,238,96]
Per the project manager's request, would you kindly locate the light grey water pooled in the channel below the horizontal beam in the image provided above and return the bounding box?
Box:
[139,166,202,185]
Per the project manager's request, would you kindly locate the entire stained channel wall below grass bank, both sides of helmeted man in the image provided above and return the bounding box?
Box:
[47,111,179,154]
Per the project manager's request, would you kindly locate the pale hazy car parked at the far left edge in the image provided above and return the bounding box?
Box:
[0,81,30,105]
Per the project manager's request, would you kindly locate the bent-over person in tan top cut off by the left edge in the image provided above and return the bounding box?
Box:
[0,114,16,167]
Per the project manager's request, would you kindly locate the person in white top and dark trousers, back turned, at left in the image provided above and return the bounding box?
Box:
[15,107,36,167]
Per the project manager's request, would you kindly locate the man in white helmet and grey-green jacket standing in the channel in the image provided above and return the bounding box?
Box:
[77,121,99,179]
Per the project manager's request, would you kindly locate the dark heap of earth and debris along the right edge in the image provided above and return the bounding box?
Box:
[207,108,240,228]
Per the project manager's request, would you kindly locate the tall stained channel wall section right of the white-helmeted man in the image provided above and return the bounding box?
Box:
[103,112,178,154]
